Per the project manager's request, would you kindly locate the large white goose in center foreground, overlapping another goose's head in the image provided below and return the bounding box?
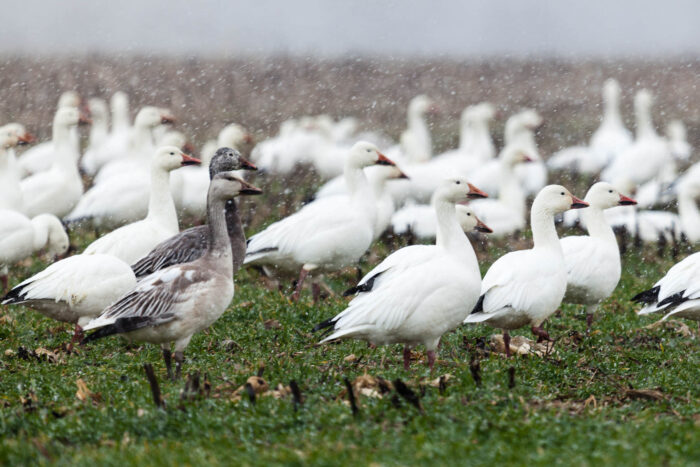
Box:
[314,178,489,371]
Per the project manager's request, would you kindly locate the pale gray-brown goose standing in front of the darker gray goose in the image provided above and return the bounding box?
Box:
[83,173,262,378]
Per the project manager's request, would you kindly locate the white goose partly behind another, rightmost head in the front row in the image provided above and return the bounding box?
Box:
[561,182,637,329]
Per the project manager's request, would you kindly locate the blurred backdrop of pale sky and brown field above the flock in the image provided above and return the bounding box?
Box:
[0,0,700,154]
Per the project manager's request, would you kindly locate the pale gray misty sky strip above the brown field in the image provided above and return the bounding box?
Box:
[0,0,700,57]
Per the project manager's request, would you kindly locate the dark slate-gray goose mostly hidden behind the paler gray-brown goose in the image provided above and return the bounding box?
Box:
[132,148,257,278]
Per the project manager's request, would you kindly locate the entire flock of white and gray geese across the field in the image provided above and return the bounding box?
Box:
[0,79,700,378]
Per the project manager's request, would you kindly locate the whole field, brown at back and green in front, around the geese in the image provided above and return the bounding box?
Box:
[0,58,700,465]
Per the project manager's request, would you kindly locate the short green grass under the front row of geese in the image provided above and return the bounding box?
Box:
[0,232,700,465]
